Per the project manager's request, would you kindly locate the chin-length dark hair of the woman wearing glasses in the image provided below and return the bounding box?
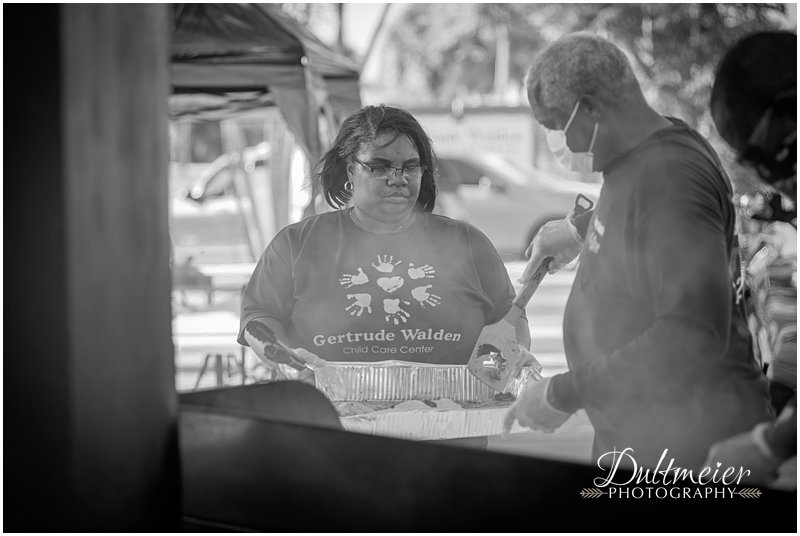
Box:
[317,104,436,212]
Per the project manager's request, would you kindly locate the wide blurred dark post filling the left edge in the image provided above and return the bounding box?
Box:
[4,4,181,532]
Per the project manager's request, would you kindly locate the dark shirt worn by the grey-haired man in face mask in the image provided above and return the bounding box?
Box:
[552,120,771,466]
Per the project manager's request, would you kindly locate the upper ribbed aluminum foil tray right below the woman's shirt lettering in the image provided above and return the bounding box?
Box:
[315,361,497,402]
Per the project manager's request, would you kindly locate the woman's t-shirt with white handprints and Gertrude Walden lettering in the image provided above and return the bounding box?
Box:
[239,211,514,364]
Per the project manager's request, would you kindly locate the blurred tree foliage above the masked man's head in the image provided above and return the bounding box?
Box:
[388,3,785,130]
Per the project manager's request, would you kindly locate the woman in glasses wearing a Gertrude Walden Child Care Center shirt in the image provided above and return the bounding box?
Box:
[239,106,530,368]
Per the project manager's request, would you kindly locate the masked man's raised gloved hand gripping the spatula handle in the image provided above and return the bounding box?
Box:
[519,217,582,284]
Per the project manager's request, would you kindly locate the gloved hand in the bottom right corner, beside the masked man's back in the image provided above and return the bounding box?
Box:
[703,423,783,486]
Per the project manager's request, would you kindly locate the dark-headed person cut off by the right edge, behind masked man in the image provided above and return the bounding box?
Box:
[706,32,797,488]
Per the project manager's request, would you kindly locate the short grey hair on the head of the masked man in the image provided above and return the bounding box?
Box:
[526,32,644,128]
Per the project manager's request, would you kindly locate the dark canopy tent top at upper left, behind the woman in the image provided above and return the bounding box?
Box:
[170,4,361,162]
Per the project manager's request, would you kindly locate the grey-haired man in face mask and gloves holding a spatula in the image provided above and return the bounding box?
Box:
[505,33,772,467]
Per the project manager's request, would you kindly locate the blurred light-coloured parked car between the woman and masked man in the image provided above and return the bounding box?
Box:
[437,152,601,258]
